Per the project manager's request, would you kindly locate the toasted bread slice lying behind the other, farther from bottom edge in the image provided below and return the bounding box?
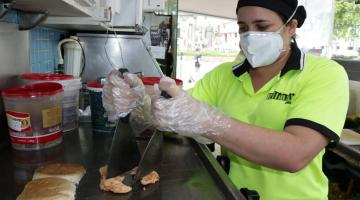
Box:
[33,163,86,184]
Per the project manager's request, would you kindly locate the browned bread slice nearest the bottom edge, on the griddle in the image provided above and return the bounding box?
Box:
[16,178,76,200]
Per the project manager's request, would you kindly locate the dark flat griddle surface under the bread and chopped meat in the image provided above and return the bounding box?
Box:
[0,124,245,200]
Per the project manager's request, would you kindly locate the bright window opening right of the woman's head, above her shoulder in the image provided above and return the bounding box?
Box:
[297,0,360,81]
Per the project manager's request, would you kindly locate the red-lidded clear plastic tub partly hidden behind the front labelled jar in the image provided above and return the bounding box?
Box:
[21,73,82,131]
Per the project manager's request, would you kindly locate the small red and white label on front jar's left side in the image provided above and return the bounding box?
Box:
[6,111,31,132]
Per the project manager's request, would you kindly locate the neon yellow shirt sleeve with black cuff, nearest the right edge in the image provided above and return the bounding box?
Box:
[285,58,349,141]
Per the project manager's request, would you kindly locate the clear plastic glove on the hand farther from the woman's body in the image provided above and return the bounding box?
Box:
[102,70,145,121]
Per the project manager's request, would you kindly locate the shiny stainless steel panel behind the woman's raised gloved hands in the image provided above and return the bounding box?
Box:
[78,33,163,82]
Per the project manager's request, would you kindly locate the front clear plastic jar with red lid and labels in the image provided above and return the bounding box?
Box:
[2,82,63,150]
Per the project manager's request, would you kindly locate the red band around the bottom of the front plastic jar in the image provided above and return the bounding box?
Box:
[10,131,63,144]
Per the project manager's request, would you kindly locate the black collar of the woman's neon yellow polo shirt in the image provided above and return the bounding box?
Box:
[232,42,305,77]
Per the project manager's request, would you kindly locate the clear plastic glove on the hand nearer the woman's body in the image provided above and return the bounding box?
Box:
[151,78,231,143]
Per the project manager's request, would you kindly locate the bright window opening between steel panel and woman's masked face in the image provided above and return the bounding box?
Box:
[176,12,239,89]
